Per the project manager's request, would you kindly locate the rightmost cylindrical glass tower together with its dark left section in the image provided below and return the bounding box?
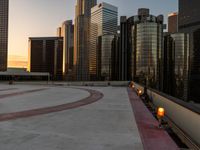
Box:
[163,33,189,101]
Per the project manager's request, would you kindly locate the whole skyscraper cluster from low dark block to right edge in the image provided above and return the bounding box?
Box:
[25,0,200,101]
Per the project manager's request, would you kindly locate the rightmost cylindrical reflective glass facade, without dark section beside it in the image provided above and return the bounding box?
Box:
[171,33,189,101]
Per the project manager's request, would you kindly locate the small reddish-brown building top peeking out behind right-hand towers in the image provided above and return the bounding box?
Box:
[168,12,178,33]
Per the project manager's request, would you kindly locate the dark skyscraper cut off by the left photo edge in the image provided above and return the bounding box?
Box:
[0,0,9,71]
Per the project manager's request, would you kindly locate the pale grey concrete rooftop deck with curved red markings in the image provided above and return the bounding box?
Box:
[0,84,176,150]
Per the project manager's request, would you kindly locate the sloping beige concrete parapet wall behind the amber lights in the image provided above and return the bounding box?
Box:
[134,83,200,145]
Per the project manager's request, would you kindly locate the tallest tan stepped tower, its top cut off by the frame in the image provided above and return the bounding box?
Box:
[73,0,97,81]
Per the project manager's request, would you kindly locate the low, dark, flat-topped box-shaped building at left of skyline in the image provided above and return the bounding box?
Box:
[28,37,63,80]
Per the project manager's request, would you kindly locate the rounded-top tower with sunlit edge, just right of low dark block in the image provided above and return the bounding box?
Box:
[61,20,74,80]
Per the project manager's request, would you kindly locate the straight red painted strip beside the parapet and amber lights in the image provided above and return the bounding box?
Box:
[128,89,179,150]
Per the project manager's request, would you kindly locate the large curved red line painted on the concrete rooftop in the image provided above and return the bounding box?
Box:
[0,88,103,121]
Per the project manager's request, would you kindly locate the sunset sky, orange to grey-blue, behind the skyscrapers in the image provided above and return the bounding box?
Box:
[8,0,178,67]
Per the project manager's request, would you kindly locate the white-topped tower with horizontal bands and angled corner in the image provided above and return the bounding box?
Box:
[89,2,118,80]
